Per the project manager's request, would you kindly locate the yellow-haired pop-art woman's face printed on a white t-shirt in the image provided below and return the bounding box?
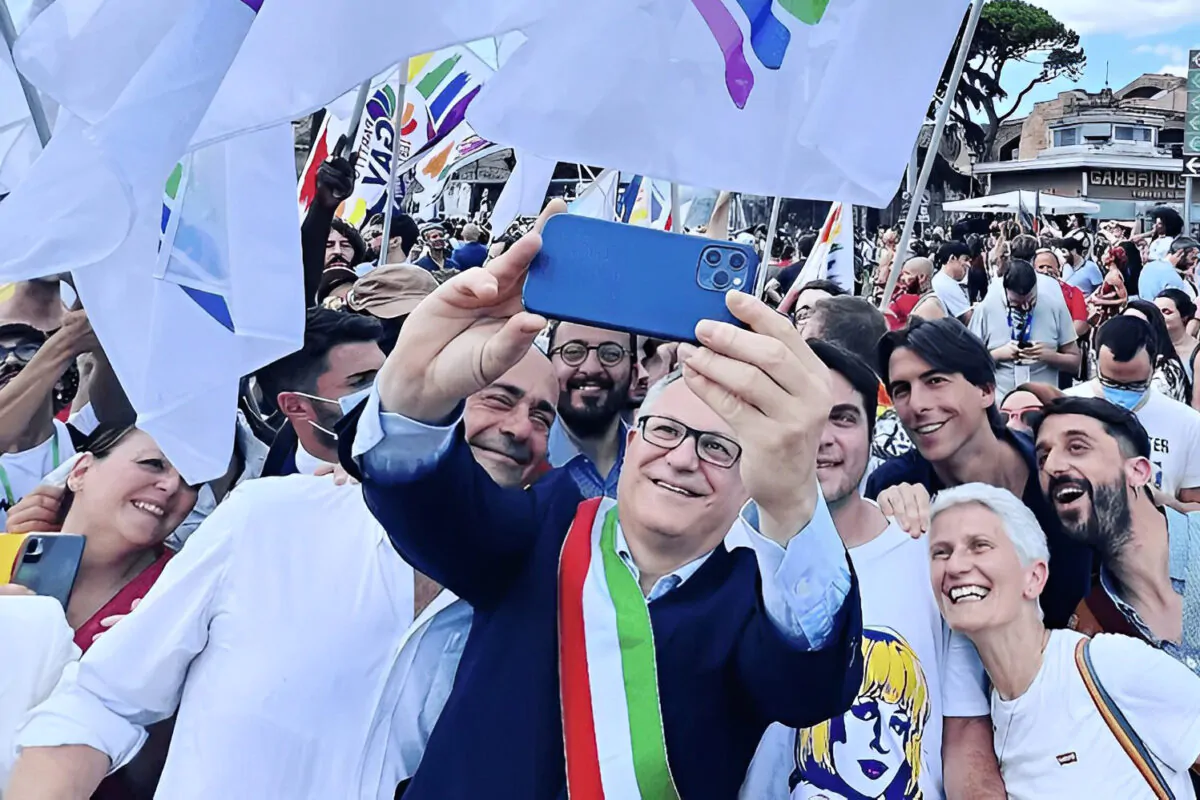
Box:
[791,628,930,800]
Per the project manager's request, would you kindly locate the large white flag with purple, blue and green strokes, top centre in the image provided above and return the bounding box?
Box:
[468,0,967,206]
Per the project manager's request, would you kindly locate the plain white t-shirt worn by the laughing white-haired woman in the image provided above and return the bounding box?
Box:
[991,631,1200,800]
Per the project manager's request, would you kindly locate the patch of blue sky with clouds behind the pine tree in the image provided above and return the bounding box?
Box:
[1000,0,1200,116]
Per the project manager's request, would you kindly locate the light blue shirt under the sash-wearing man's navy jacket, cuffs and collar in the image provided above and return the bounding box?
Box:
[352,387,851,650]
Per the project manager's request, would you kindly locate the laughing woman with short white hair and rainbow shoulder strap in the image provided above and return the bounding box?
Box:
[929,483,1200,799]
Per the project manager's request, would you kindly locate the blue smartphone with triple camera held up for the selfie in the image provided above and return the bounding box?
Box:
[522,213,758,342]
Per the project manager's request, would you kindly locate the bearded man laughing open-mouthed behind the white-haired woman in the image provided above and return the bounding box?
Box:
[1033,397,1200,675]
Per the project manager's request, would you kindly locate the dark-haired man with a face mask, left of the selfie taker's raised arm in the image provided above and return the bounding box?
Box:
[257,308,384,477]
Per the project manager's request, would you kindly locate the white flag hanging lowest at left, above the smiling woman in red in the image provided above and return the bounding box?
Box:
[76,125,305,483]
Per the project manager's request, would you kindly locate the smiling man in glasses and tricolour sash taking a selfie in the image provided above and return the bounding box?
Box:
[344,201,862,800]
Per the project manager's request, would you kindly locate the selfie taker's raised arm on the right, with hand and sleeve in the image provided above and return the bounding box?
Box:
[680,291,863,727]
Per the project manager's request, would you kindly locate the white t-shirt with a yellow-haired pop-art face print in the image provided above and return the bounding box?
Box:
[740,523,988,800]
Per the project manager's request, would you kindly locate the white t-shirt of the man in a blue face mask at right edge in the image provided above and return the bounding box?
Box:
[1064,380,1200,497]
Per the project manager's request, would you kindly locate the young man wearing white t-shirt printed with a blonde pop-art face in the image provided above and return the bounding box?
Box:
[742,338,1004,800]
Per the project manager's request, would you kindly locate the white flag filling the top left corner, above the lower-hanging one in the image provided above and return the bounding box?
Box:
[0,0,262,281]
